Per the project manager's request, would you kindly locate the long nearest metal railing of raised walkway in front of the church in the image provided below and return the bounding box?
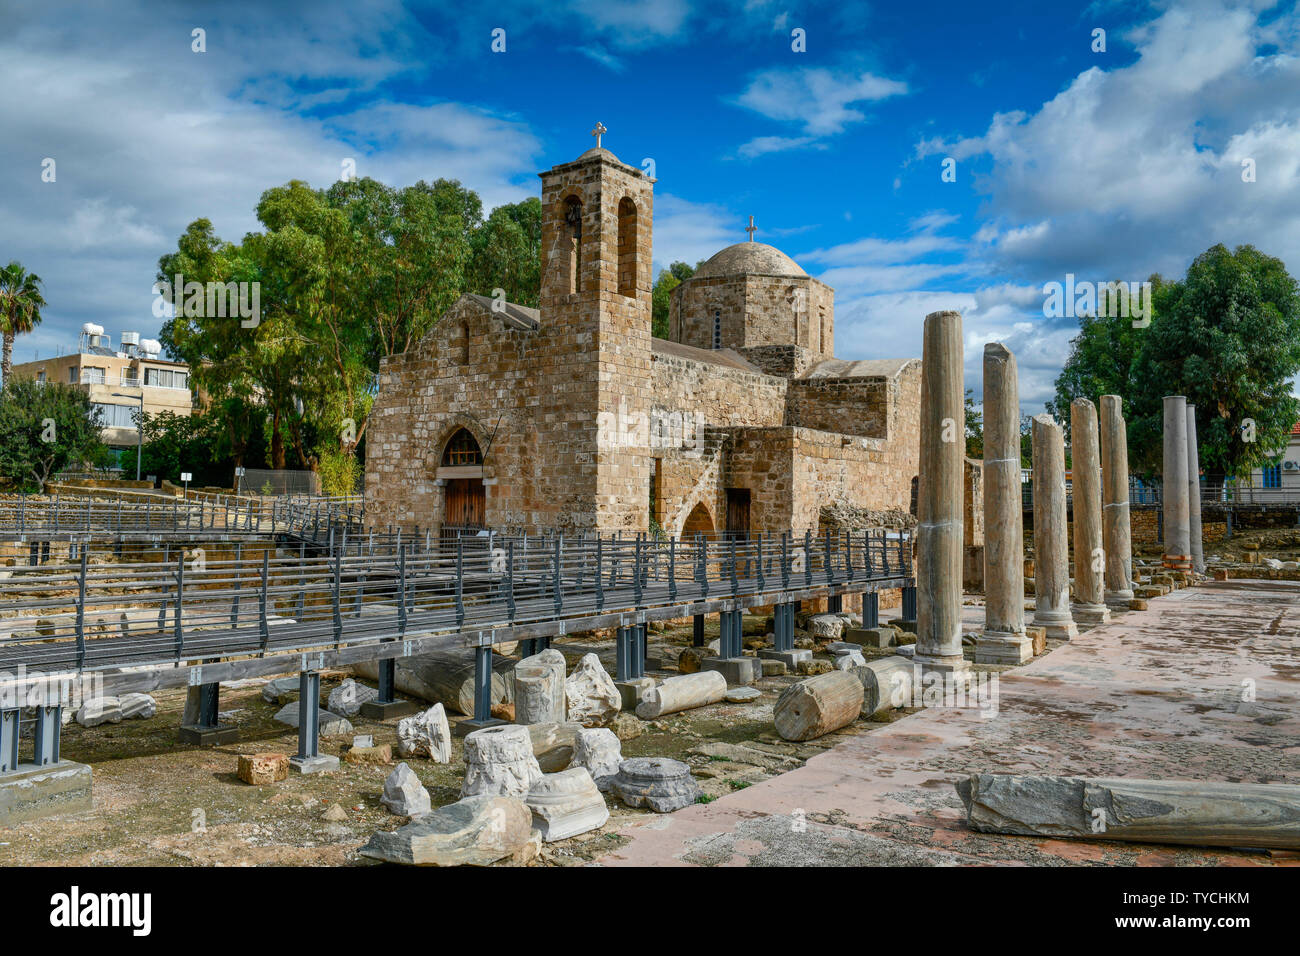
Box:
[0,531,913,674]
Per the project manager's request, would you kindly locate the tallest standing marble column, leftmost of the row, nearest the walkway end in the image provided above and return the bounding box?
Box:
[914,312,970,674]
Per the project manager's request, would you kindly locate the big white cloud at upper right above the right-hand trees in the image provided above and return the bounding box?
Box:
[917,0,1300,281]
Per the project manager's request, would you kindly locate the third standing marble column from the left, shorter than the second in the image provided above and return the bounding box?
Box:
[1031,415,1079,641]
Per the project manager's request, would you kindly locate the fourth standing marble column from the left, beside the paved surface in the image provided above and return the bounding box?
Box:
[1070,398,1110,624]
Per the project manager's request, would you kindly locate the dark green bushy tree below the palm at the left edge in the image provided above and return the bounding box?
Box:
[0,378,105,489]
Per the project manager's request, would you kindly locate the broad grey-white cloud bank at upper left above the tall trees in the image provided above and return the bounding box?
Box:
[0,4,541,360]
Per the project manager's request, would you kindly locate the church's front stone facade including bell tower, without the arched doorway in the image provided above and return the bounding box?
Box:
[367,152,654,531]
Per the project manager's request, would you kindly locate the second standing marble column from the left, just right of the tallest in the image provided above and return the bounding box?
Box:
[975,342,1034,663]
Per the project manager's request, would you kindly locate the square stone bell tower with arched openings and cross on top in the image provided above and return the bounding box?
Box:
[538,124,654,532]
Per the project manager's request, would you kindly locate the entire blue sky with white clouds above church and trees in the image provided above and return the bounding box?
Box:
[0,0,1300,411]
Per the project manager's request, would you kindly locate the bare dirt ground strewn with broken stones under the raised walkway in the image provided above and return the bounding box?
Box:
[0,615,911,866]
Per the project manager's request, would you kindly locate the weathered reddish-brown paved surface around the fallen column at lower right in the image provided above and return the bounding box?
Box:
[601,580,1300,866]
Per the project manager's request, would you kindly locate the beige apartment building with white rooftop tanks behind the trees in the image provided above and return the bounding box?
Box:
[13,323,195,467]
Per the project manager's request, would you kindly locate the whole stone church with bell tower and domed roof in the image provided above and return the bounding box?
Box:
[365,140,920,536]
